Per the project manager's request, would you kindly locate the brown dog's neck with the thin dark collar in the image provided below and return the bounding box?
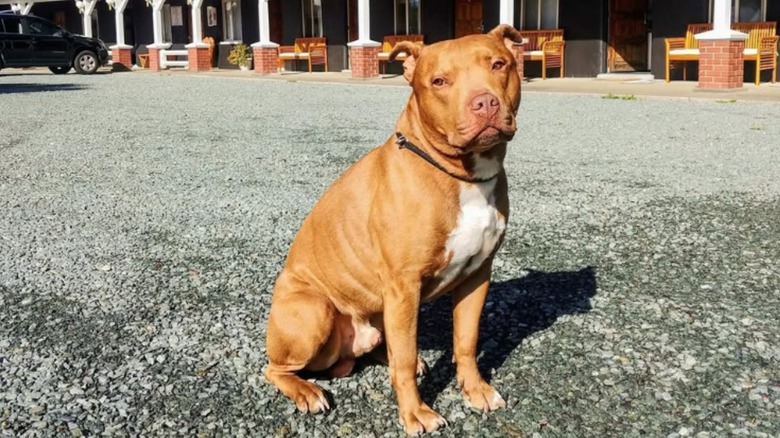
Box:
[396,94,506,181]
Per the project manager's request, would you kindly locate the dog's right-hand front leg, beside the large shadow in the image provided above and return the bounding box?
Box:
[452,262,506,412]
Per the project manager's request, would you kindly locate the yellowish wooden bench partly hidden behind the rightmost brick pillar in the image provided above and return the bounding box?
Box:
[666,21,778,85]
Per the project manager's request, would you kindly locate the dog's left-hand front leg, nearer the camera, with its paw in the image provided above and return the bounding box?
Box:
[383,279,446,434]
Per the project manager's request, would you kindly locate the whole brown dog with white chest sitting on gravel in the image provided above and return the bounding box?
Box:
[265,25,521,433]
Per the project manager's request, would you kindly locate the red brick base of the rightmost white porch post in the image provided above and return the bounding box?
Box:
[699,39,745,90]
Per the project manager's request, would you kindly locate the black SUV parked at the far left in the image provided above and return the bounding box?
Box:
[0,11,108,74]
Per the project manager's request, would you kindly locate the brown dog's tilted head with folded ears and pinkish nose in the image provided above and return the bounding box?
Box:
[390,25,522,154]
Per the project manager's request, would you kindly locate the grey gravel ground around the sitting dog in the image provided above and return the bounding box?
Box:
[0,73,780,437]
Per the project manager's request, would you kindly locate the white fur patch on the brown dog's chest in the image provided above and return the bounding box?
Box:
[434,179,506,293]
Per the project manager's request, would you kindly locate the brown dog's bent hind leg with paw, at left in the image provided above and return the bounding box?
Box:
[265,285,339,413]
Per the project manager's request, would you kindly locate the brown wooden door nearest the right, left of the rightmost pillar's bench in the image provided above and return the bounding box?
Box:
[607,0,649,72]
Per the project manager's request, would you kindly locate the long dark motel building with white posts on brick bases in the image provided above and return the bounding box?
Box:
[0,0,780,88]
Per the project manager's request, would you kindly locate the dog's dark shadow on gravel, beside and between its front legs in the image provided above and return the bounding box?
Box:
[419,267,597,406]
